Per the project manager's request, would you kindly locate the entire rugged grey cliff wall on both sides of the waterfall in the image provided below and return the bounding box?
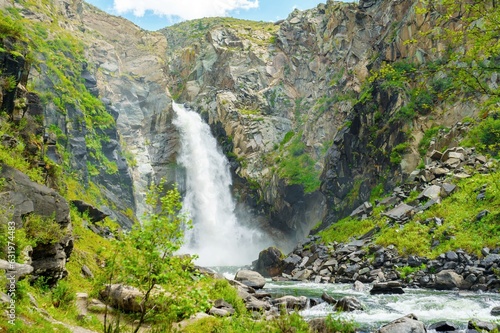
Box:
[2,0,490,241]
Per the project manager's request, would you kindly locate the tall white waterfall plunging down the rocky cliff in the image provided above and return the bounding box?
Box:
[172,103,265,266]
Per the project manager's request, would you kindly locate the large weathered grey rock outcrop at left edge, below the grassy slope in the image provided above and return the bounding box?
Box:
[0,165,73,283]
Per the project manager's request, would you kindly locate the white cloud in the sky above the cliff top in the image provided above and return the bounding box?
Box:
[114,0,259,20]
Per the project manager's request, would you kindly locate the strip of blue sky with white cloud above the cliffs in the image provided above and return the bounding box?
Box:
[86,0,340,30]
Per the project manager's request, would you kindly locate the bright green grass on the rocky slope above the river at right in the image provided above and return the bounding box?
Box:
[319,171,500,258]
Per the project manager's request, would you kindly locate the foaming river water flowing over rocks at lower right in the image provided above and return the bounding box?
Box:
[216,267,500,332]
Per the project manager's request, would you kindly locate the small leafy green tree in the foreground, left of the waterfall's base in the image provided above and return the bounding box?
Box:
[99,181,197,333]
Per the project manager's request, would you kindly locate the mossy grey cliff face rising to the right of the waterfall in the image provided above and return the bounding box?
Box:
[157,0,484,238]
